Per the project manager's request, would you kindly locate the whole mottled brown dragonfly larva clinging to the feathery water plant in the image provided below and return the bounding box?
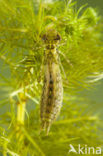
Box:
[40,29,63,133]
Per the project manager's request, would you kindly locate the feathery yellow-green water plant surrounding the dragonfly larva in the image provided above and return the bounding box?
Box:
[0,0,103,156]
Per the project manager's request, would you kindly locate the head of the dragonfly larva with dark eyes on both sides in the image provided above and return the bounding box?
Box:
[42,28,61,46]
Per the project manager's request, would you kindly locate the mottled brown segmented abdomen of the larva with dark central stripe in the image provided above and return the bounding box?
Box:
[40,50,63,133]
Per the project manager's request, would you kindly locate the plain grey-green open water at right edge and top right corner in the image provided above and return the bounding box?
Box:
[77,0,103,118]
